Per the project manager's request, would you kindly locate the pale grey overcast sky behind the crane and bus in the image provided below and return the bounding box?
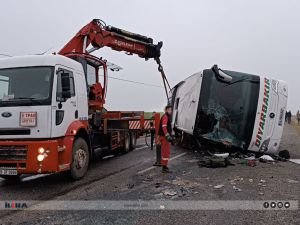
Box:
[0,0,300,111]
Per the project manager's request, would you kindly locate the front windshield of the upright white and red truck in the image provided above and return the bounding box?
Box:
[0,67,54,106]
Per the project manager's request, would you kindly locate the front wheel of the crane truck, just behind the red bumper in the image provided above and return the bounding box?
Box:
[70,138,90,180]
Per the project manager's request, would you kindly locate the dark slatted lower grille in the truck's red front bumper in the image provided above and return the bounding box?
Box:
[0,145,27,161]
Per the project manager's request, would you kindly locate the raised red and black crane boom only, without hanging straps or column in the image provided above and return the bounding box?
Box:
[59,19,162,59]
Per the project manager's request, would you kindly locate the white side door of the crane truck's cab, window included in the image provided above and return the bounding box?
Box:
[51,66,79,137]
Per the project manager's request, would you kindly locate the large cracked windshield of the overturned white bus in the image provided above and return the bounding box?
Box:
[195,70,260,148]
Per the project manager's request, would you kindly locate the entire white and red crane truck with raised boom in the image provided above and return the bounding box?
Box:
[0,19,169,180]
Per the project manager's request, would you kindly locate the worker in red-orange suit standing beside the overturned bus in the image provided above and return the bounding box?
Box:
[158,105,172,173]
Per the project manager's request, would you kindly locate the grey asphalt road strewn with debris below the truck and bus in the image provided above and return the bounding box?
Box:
[0,125,300,225]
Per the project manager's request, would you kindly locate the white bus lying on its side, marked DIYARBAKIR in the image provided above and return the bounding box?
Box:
[169,65,288,154]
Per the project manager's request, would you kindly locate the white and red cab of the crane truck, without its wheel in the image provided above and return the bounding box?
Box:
[0,55,88,179]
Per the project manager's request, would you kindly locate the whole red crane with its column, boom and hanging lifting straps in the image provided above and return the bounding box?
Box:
[58,19,171,109]
